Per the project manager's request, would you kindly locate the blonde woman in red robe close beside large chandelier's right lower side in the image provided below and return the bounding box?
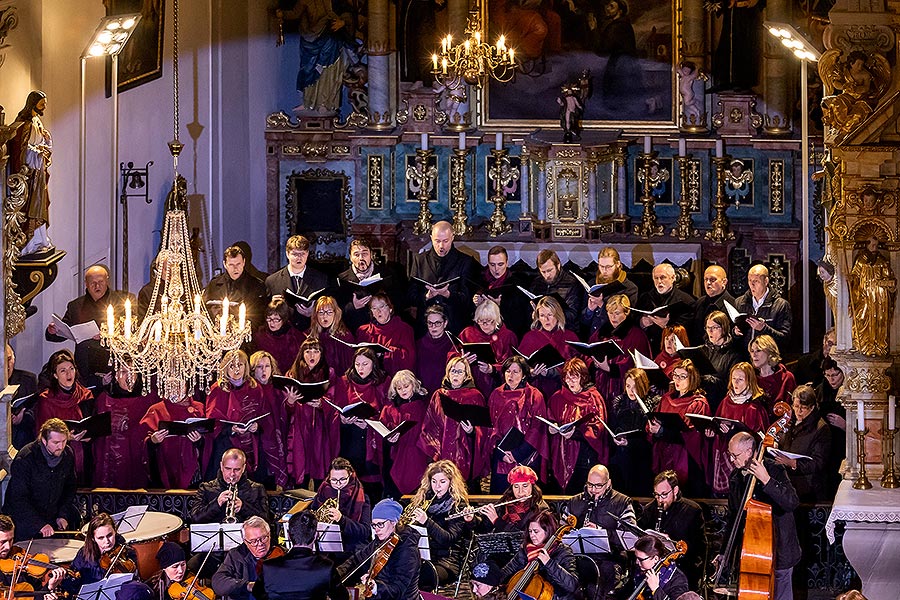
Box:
[206,350,264,479]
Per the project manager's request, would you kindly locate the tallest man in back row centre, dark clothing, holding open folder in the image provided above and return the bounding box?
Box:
[407,221,479,336]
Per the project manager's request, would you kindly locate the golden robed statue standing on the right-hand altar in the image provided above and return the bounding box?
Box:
[849,236,897,356]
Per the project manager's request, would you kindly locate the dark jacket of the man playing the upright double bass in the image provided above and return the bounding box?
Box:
[728,458,800,570]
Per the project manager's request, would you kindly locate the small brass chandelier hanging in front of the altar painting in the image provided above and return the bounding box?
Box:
[431,2,516,89]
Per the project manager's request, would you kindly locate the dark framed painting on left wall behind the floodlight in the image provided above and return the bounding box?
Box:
[104,0,166,97]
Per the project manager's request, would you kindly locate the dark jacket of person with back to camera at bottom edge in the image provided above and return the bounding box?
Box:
[253,547,348,600]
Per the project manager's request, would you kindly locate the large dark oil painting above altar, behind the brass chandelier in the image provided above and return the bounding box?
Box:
[481,0,681,128]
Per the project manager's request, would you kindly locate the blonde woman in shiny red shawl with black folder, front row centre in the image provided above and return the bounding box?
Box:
[419,356,489,489]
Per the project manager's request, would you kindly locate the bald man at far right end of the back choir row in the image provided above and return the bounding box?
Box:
[735,265,793,354]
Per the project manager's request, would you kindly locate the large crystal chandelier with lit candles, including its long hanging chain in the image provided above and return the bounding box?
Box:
[100,0,251,398]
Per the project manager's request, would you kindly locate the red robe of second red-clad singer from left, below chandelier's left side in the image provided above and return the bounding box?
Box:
[93,381,159,490]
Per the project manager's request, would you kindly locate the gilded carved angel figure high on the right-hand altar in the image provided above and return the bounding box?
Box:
[819,50,891,133]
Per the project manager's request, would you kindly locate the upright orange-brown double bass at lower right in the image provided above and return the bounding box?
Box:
[712,402,791,600]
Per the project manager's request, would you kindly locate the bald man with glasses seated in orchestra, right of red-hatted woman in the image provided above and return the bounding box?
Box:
[567,465,637,598]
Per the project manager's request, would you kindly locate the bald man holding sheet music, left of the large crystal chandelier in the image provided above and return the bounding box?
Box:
[44,265,134,386]
